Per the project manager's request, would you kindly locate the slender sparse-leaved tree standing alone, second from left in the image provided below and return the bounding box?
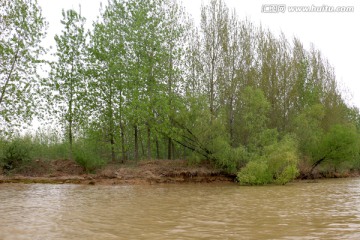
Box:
[49,9,86,154]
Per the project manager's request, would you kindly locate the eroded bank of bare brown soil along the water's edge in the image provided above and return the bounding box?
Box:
[0,160,234,185]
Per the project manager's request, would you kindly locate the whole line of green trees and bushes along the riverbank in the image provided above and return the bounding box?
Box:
[0,0,360,184]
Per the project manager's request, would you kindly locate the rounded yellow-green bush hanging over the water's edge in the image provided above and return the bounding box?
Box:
[237,136,299,185]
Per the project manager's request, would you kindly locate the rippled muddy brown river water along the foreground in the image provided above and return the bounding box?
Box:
[0,179,360,239]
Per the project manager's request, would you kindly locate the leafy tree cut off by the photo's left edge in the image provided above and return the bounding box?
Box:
[0,0,46,131]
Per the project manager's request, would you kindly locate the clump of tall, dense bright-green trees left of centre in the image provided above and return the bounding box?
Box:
[89,0,188,160]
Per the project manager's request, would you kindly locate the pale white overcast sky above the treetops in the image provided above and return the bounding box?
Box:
[38,0,360,108]
